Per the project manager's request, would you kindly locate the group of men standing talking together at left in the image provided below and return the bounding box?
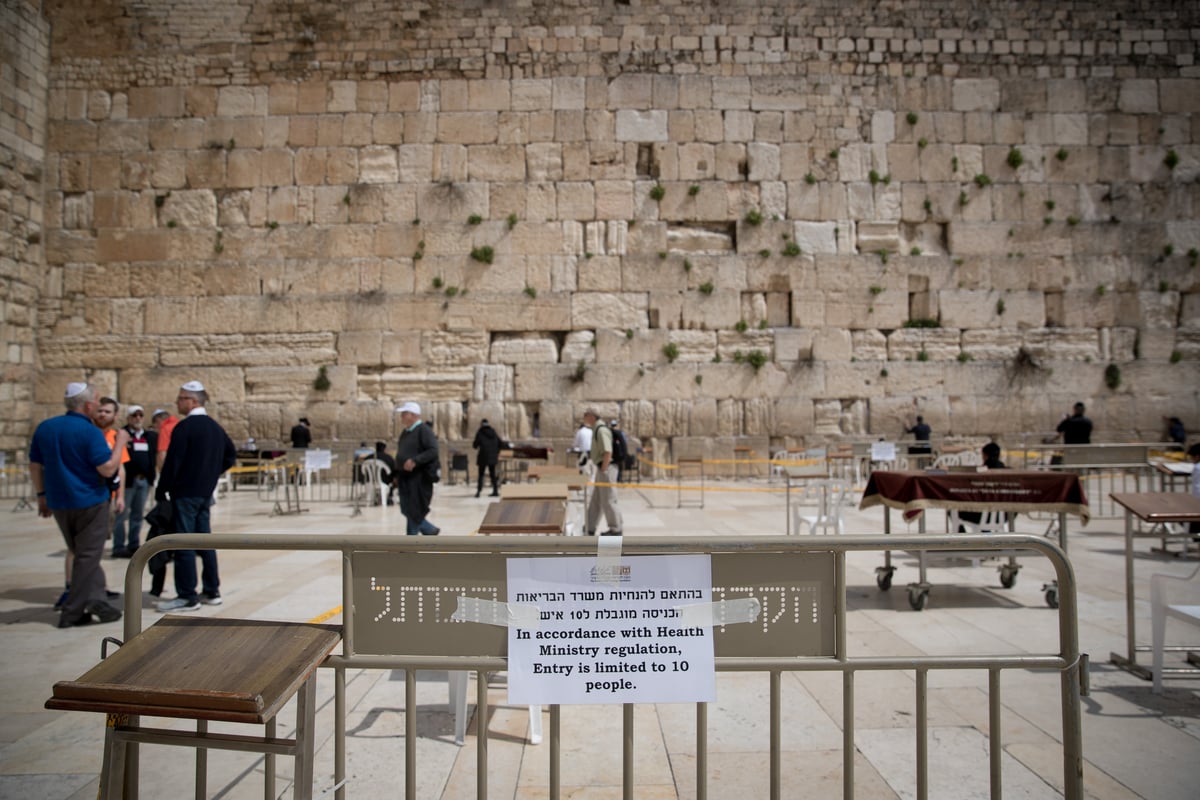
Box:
[29,380,236,627]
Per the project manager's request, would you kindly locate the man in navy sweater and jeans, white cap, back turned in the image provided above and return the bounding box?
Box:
[155,380,238,612]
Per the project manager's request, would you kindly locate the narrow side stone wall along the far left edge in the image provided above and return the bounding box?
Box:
[0,0,50,450]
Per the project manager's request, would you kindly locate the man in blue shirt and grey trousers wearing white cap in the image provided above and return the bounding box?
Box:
[29,383,130,627]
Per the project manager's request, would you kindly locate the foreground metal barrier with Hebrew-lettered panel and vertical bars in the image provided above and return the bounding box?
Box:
[124,534,1087,800]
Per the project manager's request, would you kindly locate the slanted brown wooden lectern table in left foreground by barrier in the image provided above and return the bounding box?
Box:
[46,616,342,800]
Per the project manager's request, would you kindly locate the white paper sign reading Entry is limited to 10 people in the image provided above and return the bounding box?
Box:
[508,554,716,705]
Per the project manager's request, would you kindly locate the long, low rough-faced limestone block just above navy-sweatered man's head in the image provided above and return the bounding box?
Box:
[160,332,338,367]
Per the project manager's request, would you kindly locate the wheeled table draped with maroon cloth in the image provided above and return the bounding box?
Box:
[858,469,1090,608]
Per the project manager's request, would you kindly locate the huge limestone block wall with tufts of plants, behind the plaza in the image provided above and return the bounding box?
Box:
[14,0,1200,453]
